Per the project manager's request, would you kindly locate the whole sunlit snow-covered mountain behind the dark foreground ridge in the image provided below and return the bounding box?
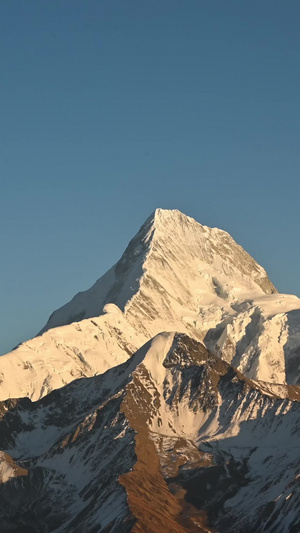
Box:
[0,209,300,400]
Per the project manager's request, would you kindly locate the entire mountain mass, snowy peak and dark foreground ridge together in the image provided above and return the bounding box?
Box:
[0,209,300,533]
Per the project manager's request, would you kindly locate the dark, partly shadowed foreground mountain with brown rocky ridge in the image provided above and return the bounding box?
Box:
[0,333,300,533]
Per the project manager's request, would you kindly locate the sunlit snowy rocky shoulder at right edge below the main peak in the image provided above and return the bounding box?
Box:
[205,294,300,384]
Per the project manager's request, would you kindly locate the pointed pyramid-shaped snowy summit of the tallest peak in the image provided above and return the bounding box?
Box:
[41,209,277,334]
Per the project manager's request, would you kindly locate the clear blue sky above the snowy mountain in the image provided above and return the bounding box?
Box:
[0,0,300,353]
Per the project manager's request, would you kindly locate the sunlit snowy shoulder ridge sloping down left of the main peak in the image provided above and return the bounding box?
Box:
[0,304,147,400]
